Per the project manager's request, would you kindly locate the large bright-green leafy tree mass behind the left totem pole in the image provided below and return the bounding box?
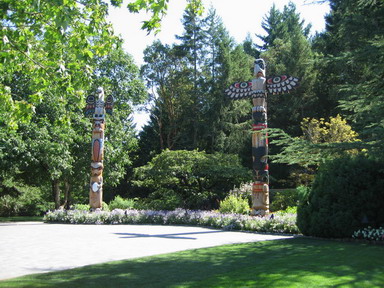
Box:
[0,0,150,207]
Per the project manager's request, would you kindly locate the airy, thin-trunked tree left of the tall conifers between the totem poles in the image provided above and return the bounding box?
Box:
[142,41,193,150]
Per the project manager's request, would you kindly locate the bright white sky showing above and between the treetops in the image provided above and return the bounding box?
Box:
[109,0,330,130]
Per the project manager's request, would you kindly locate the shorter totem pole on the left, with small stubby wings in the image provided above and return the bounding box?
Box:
[85,87,113,210]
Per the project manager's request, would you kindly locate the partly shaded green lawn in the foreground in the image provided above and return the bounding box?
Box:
[0,238,384,288]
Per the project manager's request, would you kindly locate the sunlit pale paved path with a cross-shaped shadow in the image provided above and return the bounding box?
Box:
[0,222,290,279]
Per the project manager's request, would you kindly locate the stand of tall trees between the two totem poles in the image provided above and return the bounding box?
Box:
[140,9,253,161]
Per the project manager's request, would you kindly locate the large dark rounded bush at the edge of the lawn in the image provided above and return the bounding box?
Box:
[297,156,384,238]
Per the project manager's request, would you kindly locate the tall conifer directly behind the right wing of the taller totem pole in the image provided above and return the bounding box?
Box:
[258,3,321,135]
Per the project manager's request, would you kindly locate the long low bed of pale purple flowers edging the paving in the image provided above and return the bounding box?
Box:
[44,209,299,234]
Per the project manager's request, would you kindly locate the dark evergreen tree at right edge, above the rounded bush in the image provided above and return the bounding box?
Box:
[315,0,384,157]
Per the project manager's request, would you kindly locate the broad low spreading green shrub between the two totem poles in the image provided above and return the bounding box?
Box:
[135,150,251,209]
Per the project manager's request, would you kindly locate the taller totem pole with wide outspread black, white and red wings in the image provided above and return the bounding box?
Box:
[225,59,299,216]
